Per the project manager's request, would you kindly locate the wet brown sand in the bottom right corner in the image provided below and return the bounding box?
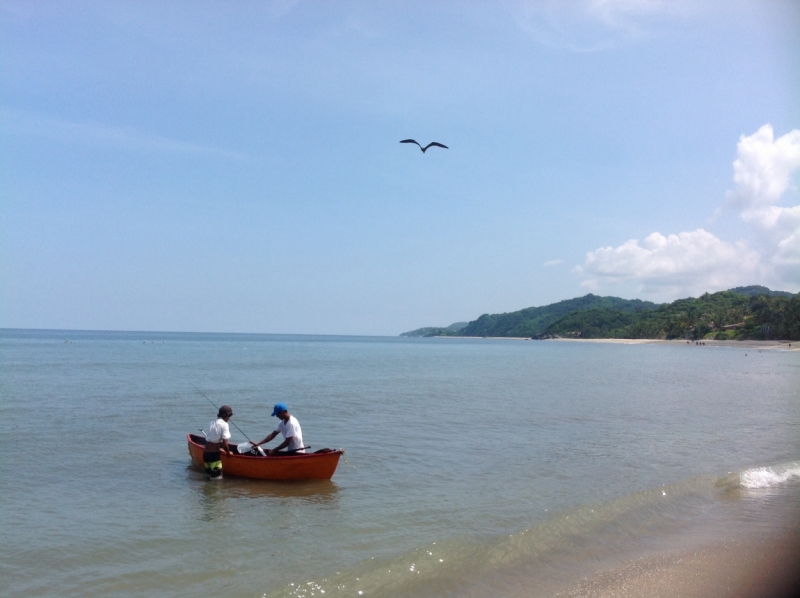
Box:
[556,528,800,598]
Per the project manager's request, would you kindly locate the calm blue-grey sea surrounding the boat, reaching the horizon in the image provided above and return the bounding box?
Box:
[0,330,800,598]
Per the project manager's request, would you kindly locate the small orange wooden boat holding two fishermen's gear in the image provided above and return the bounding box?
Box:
[187,434,343,480]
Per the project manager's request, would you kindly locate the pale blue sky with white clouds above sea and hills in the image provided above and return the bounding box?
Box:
[0,0,800,335]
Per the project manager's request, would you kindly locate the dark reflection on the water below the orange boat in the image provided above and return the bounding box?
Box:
[186,465,339,521]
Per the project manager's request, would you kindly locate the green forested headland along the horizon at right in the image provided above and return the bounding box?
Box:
[400,285,800,340]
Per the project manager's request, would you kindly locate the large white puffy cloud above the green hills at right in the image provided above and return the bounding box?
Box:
[575,125,800,298]
